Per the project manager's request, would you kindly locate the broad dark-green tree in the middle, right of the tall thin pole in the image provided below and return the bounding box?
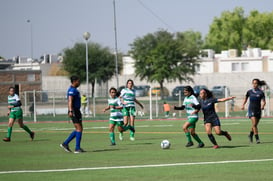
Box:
[129,30,201,99]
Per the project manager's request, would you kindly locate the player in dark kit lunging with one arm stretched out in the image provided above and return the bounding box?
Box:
[200,89,235,149]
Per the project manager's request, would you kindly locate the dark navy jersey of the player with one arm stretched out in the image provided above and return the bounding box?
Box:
[200,97,219,121]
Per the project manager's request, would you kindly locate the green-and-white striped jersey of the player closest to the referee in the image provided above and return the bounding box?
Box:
[108,97,123,121]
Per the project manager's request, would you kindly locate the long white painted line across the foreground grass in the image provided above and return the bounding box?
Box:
[0,159,273,174]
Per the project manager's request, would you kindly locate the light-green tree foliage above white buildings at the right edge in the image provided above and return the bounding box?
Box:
[204,7,273,54]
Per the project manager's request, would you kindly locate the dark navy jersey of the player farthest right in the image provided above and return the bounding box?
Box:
[246,88,265,111]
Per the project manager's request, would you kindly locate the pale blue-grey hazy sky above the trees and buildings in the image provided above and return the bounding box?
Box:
[0,0,273,59]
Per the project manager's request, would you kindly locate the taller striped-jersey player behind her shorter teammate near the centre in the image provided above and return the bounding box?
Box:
[119,79,143,141]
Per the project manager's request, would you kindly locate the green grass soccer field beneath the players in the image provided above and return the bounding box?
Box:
[0,115,273,181]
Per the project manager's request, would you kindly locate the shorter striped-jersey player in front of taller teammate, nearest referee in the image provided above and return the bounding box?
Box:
[103,87,135,146]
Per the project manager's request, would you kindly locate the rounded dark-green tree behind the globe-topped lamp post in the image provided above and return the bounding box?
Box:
[63,43,122,97]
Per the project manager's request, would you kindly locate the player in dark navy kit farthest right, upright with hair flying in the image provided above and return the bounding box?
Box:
[242,79,266,144]
